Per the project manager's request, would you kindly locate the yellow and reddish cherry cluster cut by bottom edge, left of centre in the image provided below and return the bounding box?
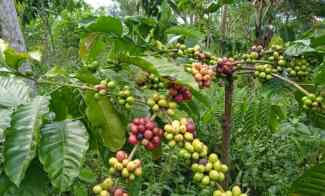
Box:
[93,177,129,196]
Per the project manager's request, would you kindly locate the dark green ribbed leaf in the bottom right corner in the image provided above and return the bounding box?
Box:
[291,164,325,196]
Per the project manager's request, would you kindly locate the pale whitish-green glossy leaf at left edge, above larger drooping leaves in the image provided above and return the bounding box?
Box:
[0,77,31,107]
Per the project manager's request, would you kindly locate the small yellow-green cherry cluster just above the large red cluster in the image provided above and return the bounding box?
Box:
[147,94,177,116]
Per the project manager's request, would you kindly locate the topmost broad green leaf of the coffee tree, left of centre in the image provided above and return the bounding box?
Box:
[81,16,123,36]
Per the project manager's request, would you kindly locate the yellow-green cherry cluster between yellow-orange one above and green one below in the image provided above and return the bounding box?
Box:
[178,139,208,160]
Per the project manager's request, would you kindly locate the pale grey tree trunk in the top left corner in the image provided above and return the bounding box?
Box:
[0,0,26,52]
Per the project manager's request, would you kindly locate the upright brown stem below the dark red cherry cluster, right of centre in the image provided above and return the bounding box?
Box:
[222,76,234,188]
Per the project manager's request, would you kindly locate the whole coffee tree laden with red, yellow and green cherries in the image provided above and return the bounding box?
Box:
[0,17,325,196]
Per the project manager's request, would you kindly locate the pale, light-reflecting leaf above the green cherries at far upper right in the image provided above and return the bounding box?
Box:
[285,40,316,56]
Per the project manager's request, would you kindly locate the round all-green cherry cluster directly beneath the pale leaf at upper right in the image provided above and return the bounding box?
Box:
[287,57,311,78]
